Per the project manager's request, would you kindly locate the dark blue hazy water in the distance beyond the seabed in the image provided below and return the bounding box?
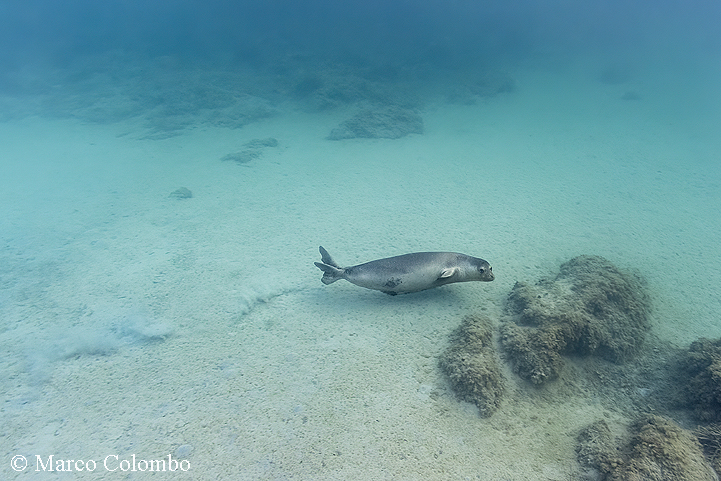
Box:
[0,0,719,83]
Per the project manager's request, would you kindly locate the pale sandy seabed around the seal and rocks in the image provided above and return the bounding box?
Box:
[0,61,721,480]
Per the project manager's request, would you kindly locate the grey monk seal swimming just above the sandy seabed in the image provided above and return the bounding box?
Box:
[315,246,494,296]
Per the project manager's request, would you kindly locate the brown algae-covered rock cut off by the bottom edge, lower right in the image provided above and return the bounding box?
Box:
[576,415,718,481]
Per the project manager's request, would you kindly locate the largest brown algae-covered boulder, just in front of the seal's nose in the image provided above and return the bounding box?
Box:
[501,256,649,384]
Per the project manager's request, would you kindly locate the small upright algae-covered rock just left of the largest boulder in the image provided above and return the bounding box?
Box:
[439,316,505,417]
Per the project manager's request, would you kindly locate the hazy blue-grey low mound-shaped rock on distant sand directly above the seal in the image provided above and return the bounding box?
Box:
[327,106,423,140]
